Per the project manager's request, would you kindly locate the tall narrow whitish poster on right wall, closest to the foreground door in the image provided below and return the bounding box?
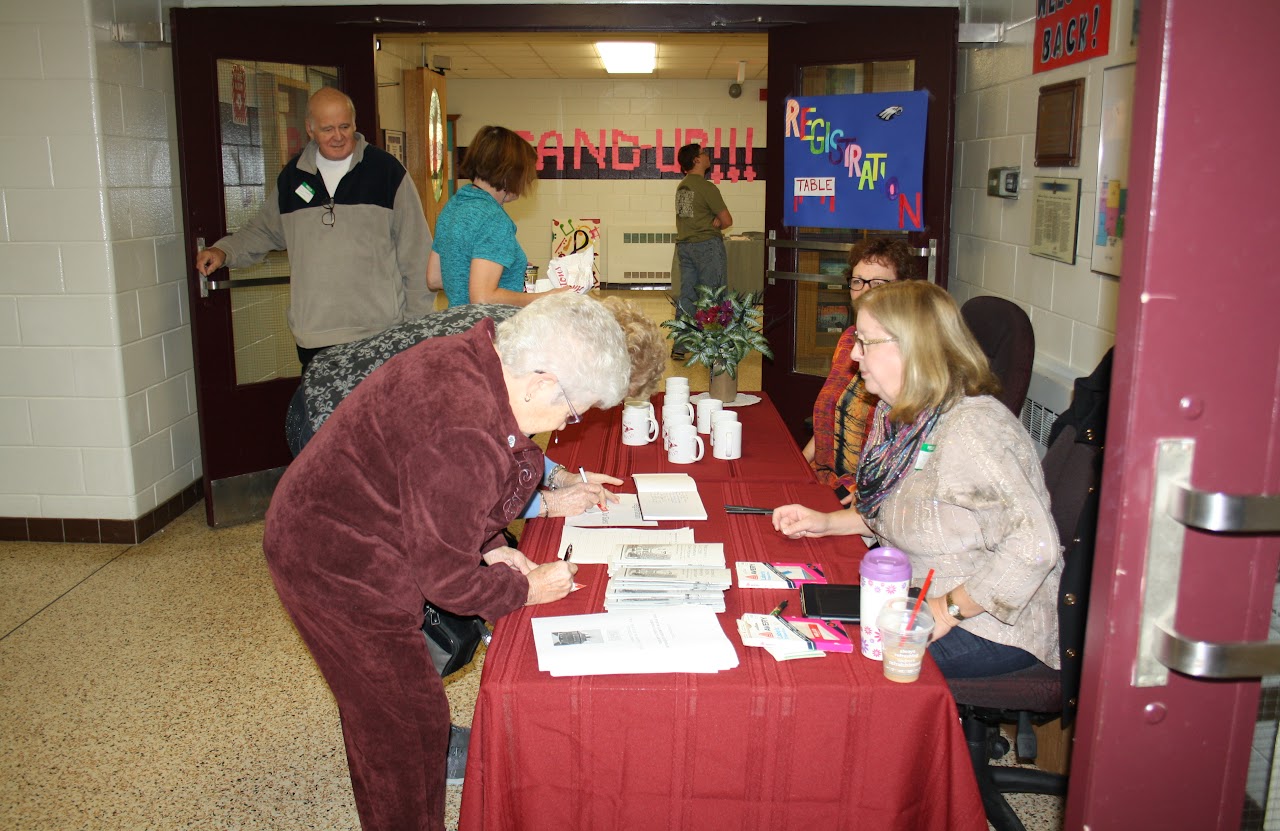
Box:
[1089,64,1134,277]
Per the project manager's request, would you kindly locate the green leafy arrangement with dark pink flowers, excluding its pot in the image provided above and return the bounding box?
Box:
[662,286,773,379]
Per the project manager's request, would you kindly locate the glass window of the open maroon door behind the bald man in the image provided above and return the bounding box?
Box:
[218,59,338,384]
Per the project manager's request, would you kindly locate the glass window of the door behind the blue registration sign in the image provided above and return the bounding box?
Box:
[791,60,923,378]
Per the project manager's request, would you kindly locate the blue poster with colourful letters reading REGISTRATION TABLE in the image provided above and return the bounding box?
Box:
[782,91,929,230]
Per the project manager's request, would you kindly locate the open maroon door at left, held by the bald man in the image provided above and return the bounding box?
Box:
[173,9,378,525]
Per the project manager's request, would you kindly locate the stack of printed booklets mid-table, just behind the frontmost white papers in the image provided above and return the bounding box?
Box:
[604,543,732,612]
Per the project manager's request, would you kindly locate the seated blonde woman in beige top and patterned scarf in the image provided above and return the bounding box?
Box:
[773,280,1062,677]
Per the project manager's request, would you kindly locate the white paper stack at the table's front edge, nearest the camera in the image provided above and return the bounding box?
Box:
[531,607,737,676]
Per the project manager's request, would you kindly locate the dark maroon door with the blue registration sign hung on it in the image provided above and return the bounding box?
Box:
[762,6,959,446]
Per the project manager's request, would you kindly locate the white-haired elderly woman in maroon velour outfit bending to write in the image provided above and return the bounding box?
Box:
[264,293,631,830]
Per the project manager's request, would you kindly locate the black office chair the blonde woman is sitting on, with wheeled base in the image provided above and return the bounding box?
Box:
[947,352,1111,831]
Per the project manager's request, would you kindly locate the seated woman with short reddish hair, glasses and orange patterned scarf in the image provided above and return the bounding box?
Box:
[804,238,915,504]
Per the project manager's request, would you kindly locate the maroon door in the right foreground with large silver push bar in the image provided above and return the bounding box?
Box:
[1065,0,1280,831]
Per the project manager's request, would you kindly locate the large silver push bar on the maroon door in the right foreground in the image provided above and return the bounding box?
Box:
[1134,439,1280,686]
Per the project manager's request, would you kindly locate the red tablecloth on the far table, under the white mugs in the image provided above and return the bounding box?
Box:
[547,392,817,492]
